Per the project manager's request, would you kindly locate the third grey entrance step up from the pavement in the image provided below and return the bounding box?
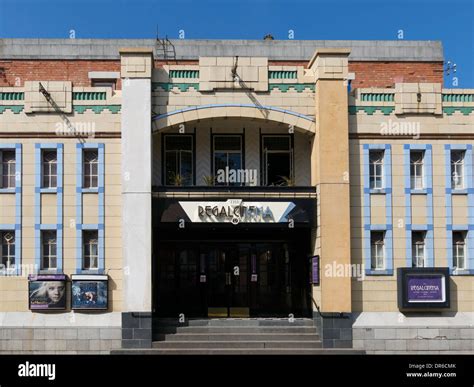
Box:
[154,333,319,341]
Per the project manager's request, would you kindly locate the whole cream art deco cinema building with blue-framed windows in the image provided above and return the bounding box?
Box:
[0,39,474,354]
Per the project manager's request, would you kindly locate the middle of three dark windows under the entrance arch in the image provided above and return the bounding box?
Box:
[213,135,242,185]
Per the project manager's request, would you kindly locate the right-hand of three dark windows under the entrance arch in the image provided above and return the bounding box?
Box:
[262,136,294,186]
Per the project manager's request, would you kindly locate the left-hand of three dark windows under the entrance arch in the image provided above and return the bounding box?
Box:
[164,134,194,186]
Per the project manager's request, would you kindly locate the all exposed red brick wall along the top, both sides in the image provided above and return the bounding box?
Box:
[0,60,443,88]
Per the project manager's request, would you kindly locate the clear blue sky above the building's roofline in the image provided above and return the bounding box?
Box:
[0,0,474,88]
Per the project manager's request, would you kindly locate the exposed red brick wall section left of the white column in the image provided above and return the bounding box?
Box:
[0,60,120,88]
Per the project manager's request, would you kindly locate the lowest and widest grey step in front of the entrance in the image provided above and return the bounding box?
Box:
[110,348,365,355]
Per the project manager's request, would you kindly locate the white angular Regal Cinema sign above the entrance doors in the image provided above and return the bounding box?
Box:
[179,199,296,224]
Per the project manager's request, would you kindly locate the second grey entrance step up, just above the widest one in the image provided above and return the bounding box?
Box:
[153,340,322,349]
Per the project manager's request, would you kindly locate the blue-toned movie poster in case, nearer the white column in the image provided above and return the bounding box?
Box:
[71,276,108,309]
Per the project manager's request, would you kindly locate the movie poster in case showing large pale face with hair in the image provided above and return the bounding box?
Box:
[28,274,66,310]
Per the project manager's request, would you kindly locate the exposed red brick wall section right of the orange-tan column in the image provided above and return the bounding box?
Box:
[349,62,443,89]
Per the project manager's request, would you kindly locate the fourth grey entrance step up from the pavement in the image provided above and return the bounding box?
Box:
[154,326,317,335]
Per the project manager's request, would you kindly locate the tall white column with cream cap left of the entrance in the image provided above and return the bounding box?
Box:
[120,48,153,316]
